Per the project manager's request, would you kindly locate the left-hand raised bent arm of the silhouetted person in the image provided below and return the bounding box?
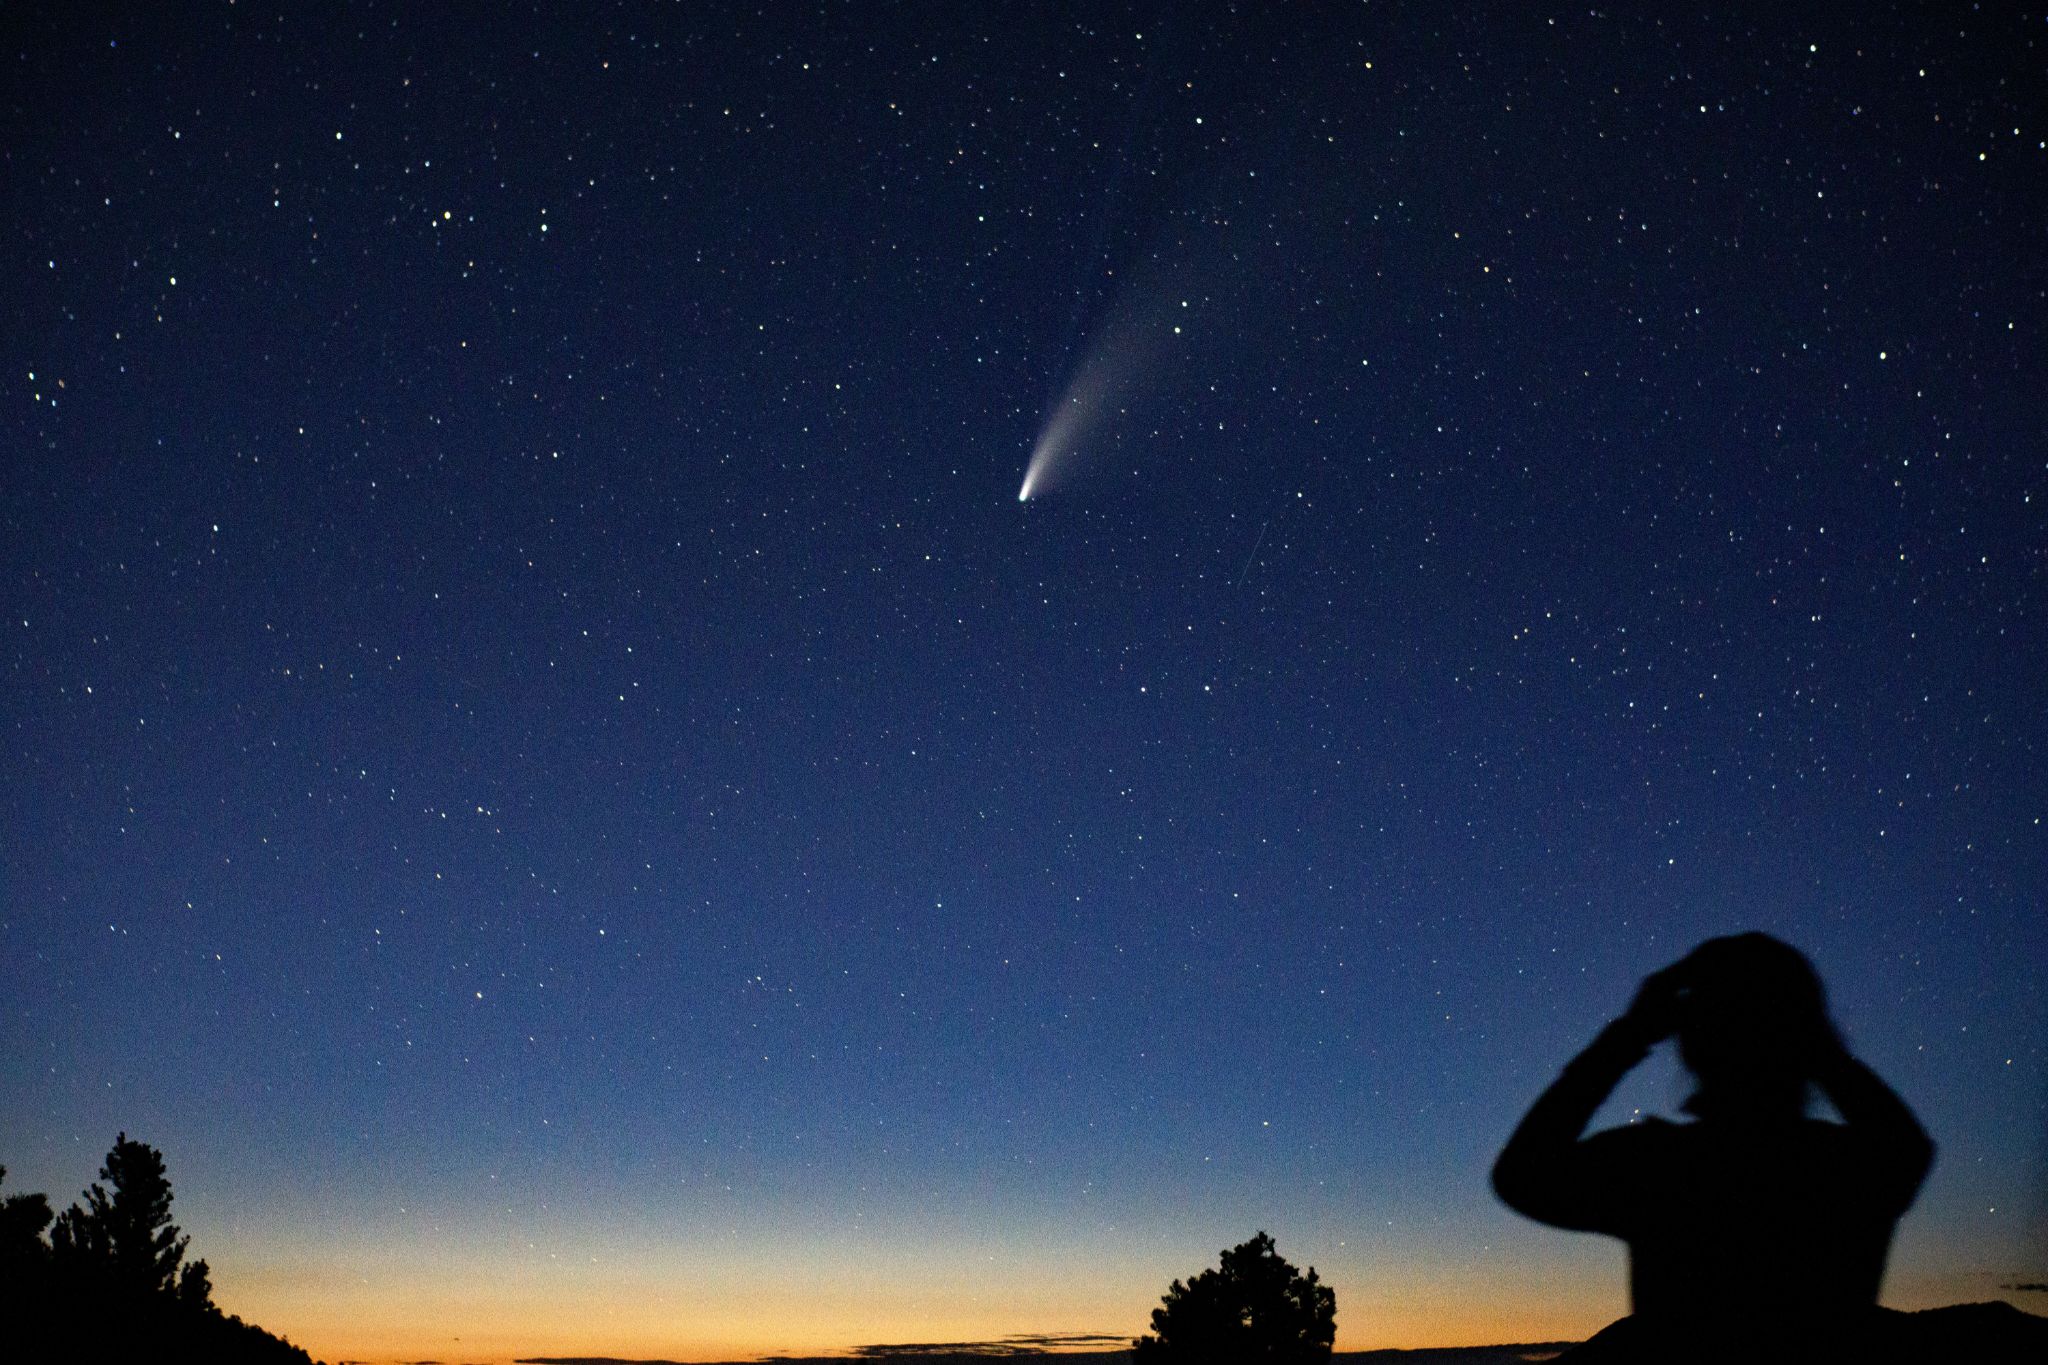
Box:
[1493,968,1679,1228]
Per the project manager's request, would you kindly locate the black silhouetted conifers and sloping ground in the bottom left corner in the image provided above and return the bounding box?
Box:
[0,1134,311,1365]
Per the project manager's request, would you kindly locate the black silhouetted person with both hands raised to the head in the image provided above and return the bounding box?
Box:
[1493,933,1933,1361]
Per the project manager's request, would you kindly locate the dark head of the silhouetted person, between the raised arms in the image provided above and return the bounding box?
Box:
[1677,933,1833,1117]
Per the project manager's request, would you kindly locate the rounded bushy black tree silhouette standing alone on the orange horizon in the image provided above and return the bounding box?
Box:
[1133,1232,1337,1365]
